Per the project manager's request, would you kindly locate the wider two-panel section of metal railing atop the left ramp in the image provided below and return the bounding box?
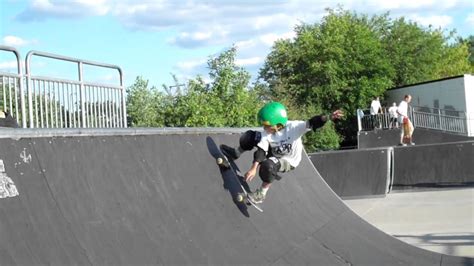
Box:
[25,51,127,128]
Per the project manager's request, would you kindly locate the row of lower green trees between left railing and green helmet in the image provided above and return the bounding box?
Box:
[127,47,261,127]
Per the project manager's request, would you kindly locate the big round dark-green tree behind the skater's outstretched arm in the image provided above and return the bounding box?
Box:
[260,10,394,149]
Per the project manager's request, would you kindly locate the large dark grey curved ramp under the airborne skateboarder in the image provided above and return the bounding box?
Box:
[0,130,473,265]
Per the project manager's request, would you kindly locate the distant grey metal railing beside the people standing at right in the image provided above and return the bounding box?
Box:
[357,106,472,135]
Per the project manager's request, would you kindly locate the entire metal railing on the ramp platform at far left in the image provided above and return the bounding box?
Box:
[0,46,127,128]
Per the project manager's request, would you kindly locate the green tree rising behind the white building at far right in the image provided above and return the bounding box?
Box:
[382,17,471,87]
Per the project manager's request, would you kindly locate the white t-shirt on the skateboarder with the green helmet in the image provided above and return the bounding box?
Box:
[257,121,311,167]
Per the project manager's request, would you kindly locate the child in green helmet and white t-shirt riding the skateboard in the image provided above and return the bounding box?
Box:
[221,102,343,203]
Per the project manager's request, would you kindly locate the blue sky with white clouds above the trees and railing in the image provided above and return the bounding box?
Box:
[0,0,474,90]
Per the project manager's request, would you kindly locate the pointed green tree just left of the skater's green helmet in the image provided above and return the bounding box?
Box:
[171,47,260,127]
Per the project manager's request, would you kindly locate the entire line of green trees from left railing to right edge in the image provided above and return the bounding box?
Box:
[127,8,474,152]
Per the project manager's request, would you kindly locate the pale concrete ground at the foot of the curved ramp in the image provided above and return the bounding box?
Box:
[345,187,474,257]
